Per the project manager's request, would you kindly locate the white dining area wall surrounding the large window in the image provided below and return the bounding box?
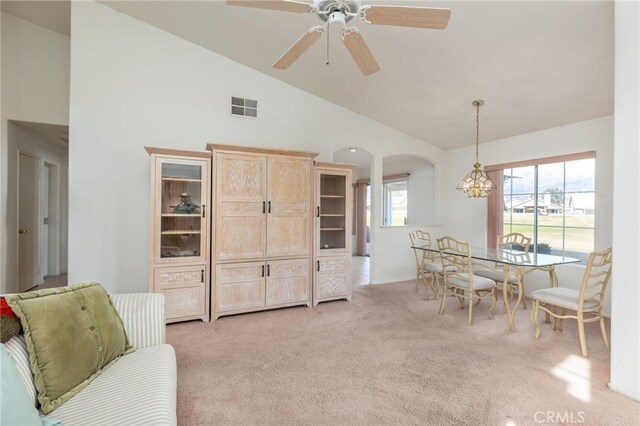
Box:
[443,116,613,315]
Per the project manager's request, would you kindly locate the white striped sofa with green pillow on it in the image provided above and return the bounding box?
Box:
[5,293,177,426]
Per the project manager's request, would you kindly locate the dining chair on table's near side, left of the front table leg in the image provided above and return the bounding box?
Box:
[438,236,497,325]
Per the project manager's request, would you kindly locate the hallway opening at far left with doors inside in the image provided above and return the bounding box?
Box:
[6,120,69,293]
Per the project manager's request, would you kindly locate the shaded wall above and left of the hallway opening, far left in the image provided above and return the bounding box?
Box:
[0,13,69,292]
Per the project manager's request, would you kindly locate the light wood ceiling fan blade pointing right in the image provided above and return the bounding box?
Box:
[358,6,451,30]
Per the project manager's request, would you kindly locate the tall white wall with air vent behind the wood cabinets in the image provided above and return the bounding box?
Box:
[69,2,442,292]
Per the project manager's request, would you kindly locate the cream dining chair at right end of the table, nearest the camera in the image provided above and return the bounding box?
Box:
[531,247,611,357]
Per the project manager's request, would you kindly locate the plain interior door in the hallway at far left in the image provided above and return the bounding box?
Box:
[18,152,40,292]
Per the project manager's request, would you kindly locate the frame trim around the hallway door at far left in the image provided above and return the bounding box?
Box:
[14,149,42,291]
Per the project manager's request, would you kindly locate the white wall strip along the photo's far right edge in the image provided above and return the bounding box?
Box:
[609,1,640,400]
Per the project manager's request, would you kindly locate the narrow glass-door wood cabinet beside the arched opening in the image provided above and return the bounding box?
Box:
[313,162,355,306]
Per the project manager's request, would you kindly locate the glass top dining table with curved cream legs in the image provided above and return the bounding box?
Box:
[411,245,580,332]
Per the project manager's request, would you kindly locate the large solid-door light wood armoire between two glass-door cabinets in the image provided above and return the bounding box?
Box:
[207,144,317,320]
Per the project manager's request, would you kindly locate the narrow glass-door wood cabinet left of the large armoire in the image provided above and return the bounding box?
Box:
[145,147,211,322]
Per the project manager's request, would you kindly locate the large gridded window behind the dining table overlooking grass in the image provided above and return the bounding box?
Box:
[488,152,595,261]
